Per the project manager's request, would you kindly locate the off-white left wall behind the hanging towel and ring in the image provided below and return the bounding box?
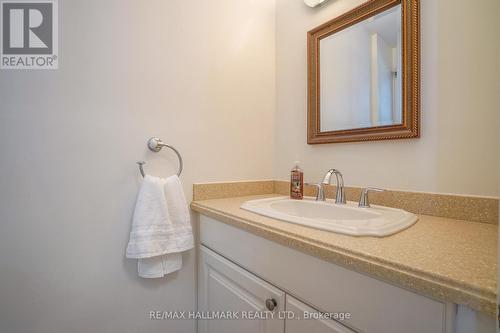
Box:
[0,0,275,333]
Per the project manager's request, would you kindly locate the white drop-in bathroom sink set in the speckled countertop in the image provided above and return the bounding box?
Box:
[241,197,418,237]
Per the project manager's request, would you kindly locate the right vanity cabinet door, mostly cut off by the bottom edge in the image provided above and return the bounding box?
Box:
[285,295,355,333]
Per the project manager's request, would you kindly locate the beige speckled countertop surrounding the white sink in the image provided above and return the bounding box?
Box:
[191,194,498,316]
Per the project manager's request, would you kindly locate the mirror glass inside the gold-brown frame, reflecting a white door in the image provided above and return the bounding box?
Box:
[319,5,402,132]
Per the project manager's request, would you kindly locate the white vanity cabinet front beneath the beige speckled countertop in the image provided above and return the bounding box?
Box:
[198,215,456,333]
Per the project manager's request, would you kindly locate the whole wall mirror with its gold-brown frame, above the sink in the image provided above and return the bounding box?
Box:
[308,0,420,144]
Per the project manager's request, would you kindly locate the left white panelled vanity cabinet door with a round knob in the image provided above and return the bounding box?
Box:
[198,246,285,333]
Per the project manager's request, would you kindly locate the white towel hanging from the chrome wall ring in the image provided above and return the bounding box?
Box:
[126,176,194,278]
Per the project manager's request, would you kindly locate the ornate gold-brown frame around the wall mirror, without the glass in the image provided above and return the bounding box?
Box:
[307,0,420,144]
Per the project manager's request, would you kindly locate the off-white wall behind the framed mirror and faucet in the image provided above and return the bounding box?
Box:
[274,0,500,195]
